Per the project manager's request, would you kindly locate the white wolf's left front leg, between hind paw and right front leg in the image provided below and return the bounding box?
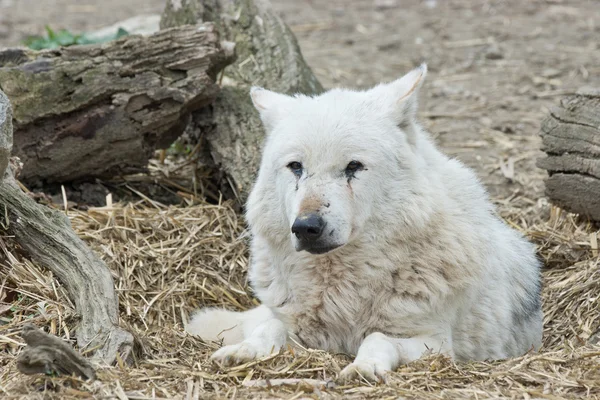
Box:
[206,306,287,365]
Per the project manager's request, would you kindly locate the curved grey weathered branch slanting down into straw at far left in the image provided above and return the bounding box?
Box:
[0,90,133,363]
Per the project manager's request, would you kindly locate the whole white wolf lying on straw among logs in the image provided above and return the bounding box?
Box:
[187,65,542,380]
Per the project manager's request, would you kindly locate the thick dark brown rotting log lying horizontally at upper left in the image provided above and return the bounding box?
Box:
[0,23,234,185]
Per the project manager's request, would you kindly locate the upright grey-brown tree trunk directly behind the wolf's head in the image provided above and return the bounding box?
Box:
[161,0,323,204]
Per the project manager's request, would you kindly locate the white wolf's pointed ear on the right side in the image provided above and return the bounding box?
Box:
[389,64,427,126]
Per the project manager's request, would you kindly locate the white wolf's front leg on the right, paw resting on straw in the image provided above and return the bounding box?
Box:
[340,332,452,382]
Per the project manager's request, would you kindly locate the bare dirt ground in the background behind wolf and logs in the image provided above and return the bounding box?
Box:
[0,0,600,197]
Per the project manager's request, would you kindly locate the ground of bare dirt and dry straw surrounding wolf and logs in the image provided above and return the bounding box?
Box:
[0,0,600,399]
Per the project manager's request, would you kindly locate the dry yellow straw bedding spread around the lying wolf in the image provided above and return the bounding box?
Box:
[0,188,600,399]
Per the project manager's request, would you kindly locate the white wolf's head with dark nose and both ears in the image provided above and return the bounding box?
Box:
[247,65,427,254]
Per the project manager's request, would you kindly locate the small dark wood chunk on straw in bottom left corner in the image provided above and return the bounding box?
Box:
[17,324,96,380]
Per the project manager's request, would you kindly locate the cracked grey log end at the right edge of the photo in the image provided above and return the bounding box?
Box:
[538,89,600,221]
